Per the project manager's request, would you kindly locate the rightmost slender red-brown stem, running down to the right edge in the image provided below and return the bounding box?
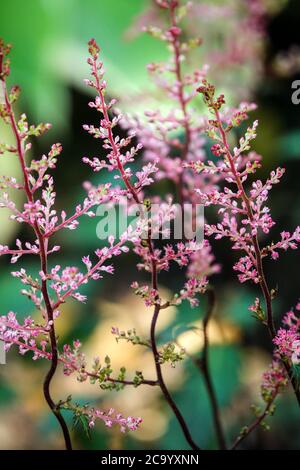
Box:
[211,103,300,406]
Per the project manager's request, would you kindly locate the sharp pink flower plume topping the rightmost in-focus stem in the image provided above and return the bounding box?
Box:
[192,80,300,283]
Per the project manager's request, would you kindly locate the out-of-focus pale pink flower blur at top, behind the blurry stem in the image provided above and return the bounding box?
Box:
[130,0,274,99]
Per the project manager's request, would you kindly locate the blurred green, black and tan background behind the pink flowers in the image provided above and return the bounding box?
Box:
[0,0,300,449]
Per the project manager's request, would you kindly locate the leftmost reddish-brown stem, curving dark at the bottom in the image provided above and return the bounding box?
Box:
[1,76,72,450]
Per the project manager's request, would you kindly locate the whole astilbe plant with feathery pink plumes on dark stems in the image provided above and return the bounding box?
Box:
[0,0,300,450]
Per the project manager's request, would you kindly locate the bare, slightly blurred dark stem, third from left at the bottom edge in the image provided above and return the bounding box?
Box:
[194,289,226,450]
